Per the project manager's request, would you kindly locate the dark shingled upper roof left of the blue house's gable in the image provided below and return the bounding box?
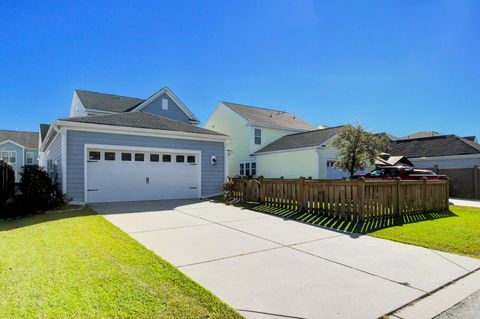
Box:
[75,90,145,112]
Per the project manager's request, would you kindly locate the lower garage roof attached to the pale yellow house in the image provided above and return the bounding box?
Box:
[255,126,343,154]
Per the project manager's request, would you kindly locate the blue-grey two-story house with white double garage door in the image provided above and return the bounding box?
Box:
[40,88,228,203]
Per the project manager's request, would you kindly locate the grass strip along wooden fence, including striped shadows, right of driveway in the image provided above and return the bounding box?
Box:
[247,205,480,258]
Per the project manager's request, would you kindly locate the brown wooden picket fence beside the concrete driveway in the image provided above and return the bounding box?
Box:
[232,178,448,222]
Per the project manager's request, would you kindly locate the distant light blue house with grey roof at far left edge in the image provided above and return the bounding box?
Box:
[0,130,38,182]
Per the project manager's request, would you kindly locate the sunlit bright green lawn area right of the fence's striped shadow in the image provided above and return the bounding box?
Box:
[369,206,480,258]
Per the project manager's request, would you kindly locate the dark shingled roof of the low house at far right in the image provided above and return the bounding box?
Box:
[388,135,480,158]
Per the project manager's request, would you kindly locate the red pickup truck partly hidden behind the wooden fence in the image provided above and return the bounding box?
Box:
[353,166,447,180]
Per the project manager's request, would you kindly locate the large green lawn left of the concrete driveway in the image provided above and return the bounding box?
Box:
[0,208,240,318]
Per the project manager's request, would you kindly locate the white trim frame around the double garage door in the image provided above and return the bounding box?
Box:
[83,144,202,203]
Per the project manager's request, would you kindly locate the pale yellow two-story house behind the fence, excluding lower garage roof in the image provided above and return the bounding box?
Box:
[205,102,317,177]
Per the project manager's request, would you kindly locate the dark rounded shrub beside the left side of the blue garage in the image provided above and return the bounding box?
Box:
[20,165,65,211]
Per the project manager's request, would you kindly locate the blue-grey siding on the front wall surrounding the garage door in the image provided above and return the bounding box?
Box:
[67,131,225,202]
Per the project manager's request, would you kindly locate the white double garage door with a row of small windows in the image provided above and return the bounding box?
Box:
[86,149,200,203]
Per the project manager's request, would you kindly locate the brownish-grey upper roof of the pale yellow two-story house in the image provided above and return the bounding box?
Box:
[221,102,317,131]
